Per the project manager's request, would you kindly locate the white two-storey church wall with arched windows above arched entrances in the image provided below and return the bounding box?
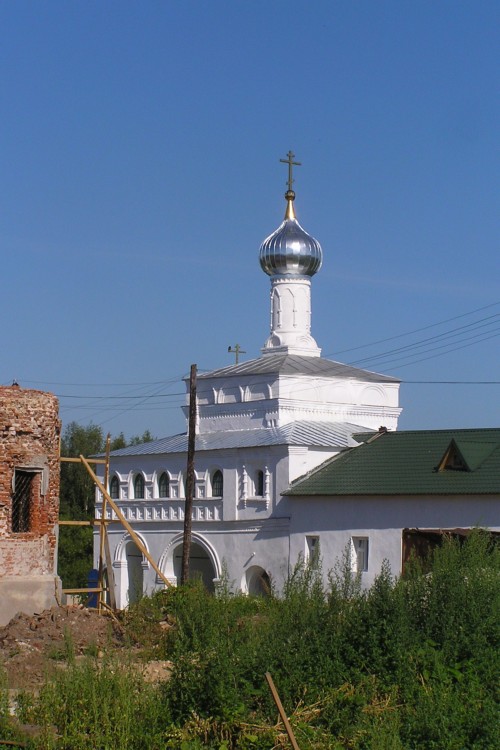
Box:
[94,446,290,608]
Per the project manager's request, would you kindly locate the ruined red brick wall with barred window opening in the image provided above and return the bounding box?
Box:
[0,386,61,578]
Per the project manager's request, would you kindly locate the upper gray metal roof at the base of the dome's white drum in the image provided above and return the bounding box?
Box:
[198,354,400,383]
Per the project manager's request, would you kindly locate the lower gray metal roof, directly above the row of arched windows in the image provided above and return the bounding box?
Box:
[111,421,363,456]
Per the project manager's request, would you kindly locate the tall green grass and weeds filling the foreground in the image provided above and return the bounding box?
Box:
[0,531,500,750]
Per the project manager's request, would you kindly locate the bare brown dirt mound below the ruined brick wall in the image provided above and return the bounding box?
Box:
[0,605,124,690]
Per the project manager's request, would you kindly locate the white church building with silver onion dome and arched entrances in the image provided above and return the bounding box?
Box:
[96,160,401,607]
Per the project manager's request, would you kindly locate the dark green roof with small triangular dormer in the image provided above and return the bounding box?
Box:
[283,429,500,497]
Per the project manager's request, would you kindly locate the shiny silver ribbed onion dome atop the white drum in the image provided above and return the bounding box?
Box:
[259,190,323,276]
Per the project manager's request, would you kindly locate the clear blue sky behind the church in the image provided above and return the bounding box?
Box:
[0,0,500,436]
